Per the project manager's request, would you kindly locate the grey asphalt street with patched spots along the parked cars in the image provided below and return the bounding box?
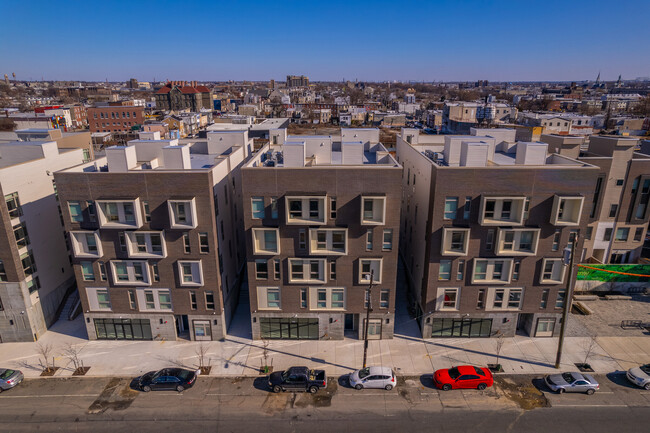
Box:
[0,374,650,433]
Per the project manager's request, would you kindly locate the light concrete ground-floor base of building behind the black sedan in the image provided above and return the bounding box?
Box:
[84,313,226,341]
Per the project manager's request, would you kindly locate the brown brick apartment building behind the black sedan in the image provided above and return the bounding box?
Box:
[55,131,250,340]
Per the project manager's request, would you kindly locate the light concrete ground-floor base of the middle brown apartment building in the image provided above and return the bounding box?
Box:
[251,311,395,340]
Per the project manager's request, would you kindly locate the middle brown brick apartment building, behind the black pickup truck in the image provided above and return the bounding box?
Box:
[242,129,401,339]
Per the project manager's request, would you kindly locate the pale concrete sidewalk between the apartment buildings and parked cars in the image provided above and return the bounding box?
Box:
[0,286,650,377]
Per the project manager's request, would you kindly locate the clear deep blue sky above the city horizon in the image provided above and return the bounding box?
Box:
[0,0,650,81]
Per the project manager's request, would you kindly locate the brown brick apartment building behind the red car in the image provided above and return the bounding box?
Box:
[397,128,598,338]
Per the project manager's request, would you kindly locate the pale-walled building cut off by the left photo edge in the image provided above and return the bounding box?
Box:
[0,140,85,343]
